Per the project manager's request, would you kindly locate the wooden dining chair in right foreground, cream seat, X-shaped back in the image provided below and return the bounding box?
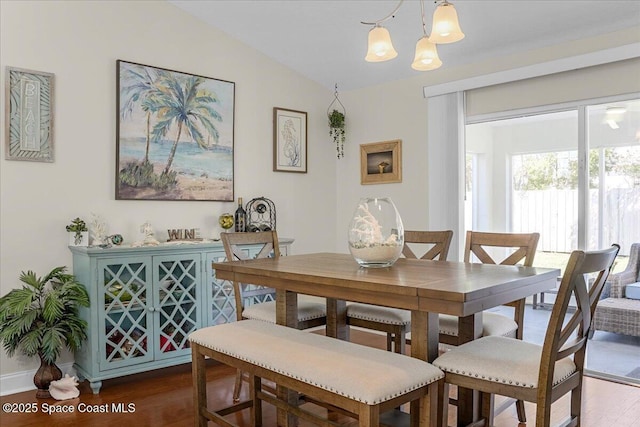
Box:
[433,244,620,427]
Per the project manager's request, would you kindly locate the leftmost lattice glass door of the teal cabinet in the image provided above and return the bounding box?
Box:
[97,257,153,370]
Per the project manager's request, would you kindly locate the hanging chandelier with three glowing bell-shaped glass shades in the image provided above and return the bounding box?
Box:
[361,0,464,71]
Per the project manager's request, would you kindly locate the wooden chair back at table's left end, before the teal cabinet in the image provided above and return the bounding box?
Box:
[220,230,280,320]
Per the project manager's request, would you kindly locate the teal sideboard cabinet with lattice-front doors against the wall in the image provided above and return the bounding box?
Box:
[69,239,293,394]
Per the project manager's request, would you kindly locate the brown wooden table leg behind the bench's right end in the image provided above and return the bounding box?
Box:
[410,311,442,427]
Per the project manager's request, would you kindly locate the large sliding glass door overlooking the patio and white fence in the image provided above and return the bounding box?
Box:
[465,97,640,383]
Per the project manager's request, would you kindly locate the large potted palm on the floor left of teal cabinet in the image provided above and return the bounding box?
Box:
[0,267,89,398]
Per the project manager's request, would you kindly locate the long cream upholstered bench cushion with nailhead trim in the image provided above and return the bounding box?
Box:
[189,320,444,405]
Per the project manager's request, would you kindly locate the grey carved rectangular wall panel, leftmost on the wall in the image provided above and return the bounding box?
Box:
[5,67,54,163]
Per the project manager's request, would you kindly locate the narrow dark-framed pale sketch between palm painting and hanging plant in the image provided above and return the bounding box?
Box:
[273,107,307,173]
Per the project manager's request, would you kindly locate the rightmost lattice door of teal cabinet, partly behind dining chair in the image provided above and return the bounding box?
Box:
[205,252,236,326]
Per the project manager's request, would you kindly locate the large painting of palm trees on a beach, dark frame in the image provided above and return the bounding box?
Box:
[116,60,235,202]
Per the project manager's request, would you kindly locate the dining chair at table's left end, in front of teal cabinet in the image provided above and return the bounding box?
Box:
[220,230,327,402]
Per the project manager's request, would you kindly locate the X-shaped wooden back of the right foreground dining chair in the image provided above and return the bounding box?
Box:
[538,244,620,398]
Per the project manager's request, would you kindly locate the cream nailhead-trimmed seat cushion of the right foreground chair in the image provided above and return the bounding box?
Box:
[433,337,576,388]
